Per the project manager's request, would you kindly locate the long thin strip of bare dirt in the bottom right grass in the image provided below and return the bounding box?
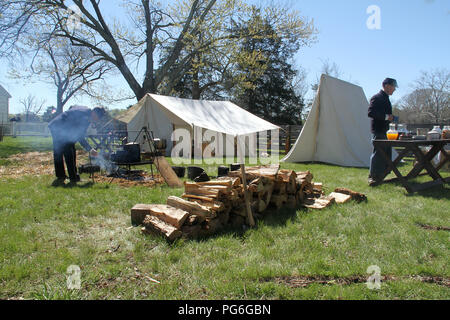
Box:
[261,275,450,288]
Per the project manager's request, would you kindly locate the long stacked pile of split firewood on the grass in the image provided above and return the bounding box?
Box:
[131,165,366,241]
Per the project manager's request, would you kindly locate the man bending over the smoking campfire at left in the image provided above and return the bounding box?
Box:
[48,106,106,185]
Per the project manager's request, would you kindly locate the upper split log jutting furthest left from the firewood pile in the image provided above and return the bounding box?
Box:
[131,204,190,228]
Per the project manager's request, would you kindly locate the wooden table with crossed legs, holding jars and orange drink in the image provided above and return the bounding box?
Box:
[373,139,450,193]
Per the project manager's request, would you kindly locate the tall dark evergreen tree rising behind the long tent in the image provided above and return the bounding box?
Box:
[234,11,304,124]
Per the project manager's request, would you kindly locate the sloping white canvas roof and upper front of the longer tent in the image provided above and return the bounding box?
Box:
[117,93,279,155]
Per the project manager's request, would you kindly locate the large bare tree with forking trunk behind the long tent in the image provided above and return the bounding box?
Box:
[0,0,314,100]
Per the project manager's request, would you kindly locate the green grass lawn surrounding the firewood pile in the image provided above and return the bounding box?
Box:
[0,137,450,299]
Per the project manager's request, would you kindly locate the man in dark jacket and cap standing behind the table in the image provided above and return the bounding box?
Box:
[368,78,398,186]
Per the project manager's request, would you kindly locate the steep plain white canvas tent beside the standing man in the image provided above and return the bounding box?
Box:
[282,74,372,167]
